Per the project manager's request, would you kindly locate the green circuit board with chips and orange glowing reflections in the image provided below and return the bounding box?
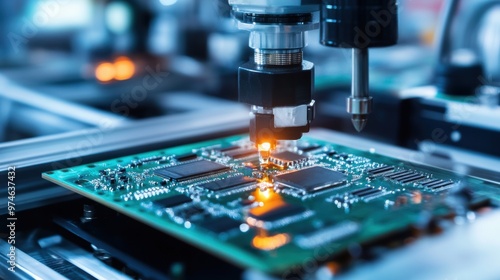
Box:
[43,135,500,277]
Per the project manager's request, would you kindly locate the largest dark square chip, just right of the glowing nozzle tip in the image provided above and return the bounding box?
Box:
[274,166,347,193]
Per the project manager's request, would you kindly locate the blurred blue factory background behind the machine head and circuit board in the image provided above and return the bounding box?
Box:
[0,0,500,278]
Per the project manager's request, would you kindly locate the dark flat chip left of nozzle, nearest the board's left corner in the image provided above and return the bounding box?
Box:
[154,160,229,181]
